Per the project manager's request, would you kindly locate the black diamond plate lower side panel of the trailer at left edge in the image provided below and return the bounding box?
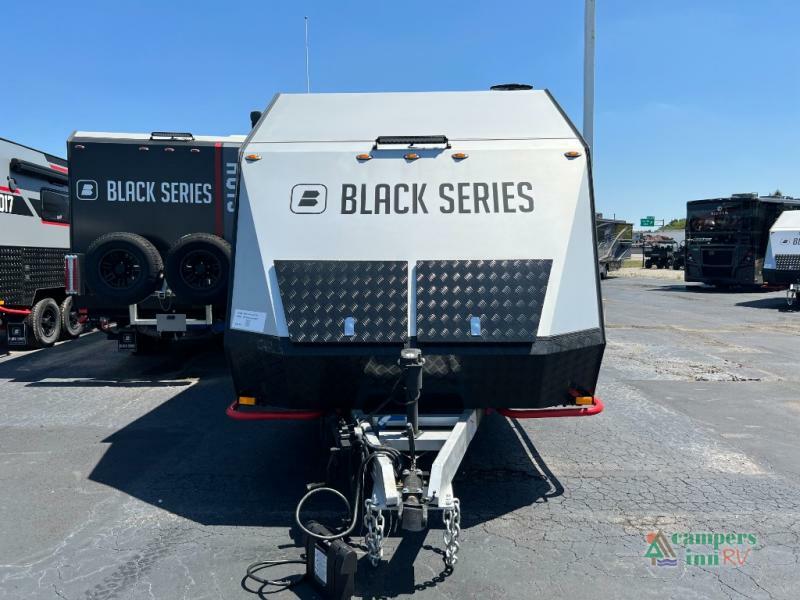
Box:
[0,246,66,306]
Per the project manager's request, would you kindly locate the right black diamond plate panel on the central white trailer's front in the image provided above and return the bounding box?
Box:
[417,260,552,342]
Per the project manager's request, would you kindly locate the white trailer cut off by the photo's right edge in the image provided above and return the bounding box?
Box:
[764,210,800,302]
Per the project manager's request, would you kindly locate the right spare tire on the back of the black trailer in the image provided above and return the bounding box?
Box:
[166,233,231,304]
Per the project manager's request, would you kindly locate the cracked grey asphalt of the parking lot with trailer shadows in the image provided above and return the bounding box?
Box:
[0,277,800,600]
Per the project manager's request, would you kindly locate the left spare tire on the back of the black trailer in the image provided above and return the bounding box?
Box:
[86,231,164,305]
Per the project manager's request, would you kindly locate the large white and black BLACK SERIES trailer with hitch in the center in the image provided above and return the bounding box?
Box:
[225,89,605,565]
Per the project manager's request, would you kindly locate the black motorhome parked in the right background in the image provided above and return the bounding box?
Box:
[684,194,800,287]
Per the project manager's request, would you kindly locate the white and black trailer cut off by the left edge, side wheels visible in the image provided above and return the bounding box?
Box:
[0,139,83,347]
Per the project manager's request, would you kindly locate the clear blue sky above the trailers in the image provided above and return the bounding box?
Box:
[0,0,800,223]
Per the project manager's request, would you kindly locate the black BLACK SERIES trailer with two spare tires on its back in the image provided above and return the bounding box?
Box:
[64,132,244,351]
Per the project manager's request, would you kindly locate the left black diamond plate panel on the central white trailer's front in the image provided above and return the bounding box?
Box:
[275,260,408,344]
